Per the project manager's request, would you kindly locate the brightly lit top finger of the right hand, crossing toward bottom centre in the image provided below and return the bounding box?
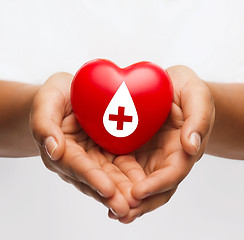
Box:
[131,150,195,199]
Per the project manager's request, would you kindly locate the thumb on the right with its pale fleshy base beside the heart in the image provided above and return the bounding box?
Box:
[167,66,214,155]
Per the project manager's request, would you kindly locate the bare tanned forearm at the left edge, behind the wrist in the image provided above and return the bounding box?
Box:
[0,81,40,157]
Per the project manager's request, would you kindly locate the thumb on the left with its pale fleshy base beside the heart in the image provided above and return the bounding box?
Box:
[30,73,72,160]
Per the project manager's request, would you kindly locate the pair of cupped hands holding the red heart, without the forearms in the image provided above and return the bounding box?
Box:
[30,66,214,223]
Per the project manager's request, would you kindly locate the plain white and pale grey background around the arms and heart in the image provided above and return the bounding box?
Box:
[0,0,244,240]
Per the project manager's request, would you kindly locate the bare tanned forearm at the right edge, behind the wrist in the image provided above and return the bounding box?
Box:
[206,83,244,160]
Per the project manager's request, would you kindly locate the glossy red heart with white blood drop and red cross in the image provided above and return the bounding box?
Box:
[71,59,173,155]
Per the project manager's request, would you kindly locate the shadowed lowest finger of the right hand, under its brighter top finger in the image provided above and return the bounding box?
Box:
[117,188,176,224]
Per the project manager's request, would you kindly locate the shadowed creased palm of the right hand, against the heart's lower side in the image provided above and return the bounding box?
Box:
[135,99,193,175]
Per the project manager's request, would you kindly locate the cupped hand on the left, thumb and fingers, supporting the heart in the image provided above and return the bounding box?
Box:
[30,73,145,217]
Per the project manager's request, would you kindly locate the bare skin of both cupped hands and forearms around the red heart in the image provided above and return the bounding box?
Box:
[0,66,240,223]
